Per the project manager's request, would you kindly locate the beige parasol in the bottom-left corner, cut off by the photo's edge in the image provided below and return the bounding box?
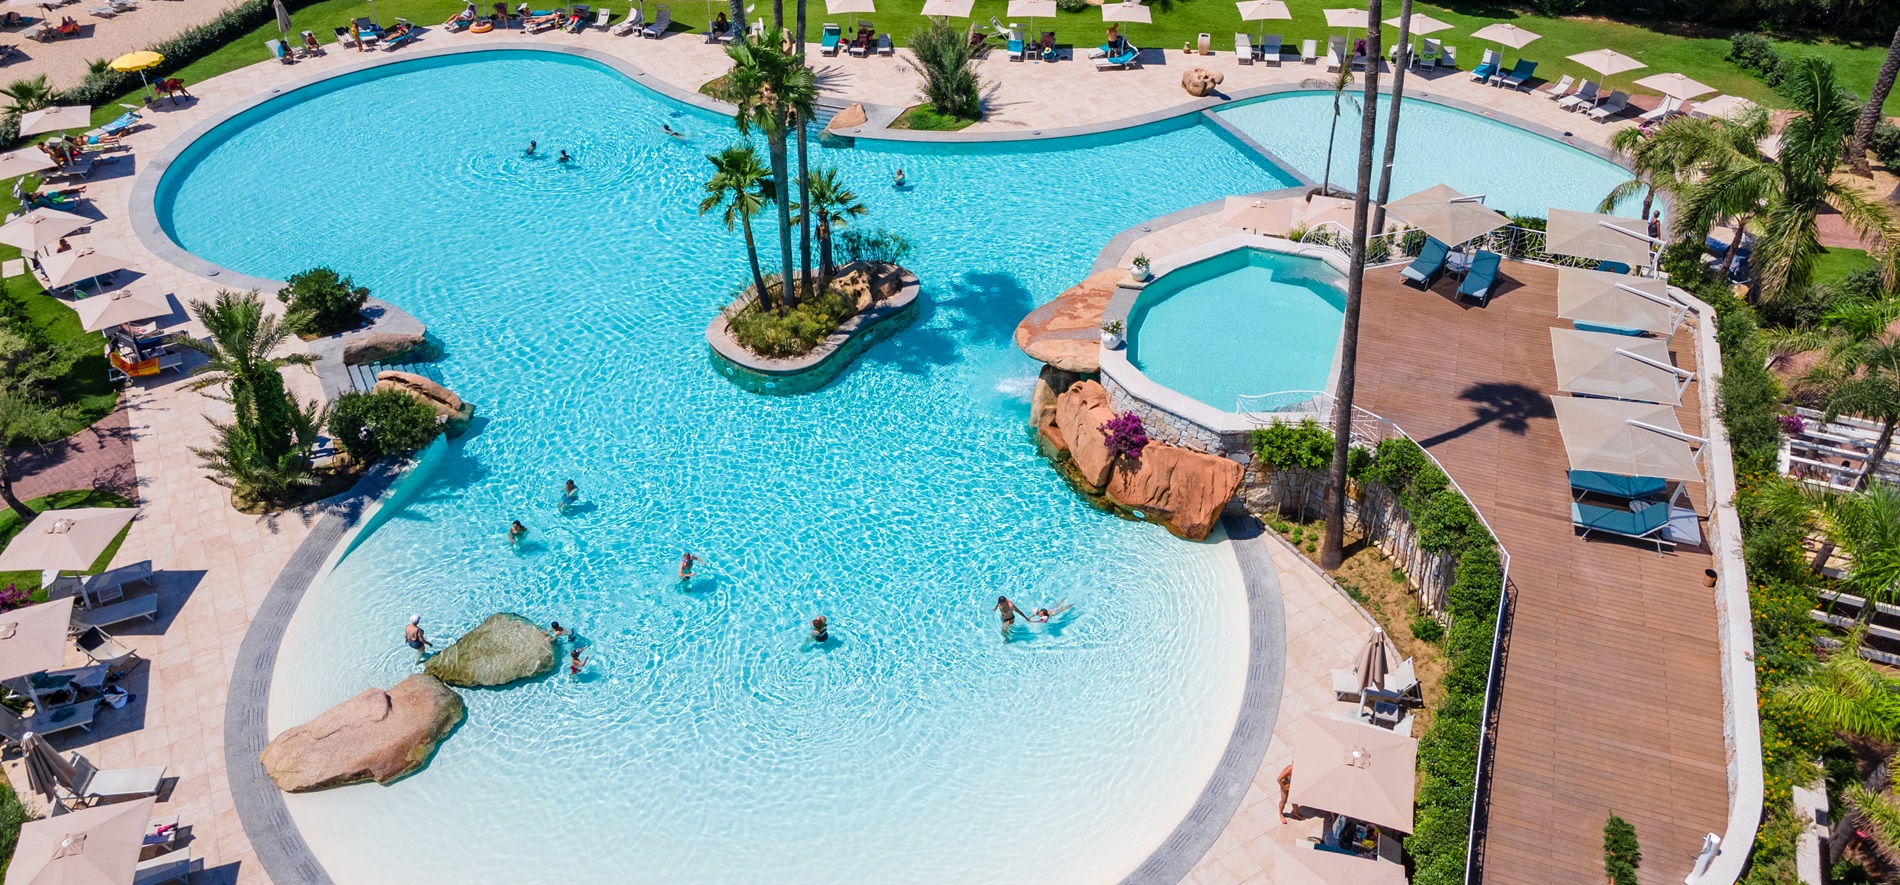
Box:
[6,796,158,885]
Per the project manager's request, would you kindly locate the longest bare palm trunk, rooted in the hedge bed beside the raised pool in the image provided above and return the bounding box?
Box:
[1319,0,1383,570]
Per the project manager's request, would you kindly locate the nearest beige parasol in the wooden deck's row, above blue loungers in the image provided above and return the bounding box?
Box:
[1550,397,1702,482]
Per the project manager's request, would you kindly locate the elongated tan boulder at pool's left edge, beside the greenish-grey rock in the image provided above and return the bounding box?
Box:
[258,672,466,792]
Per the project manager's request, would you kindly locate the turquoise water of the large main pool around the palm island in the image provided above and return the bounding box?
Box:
[158,53,1286,885]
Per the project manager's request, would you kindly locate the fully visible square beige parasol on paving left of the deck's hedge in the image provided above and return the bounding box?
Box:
[1292,712,1419,832]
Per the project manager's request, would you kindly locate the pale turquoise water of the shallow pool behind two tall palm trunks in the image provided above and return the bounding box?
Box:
[1218,90,1640,217]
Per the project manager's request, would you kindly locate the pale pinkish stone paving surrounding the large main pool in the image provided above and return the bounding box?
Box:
[10,27,1649,881]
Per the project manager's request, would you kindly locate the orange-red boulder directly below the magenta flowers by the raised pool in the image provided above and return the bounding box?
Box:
[1102,442,1246,541]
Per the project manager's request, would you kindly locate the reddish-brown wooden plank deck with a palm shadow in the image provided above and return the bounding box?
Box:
[1357,262,1729,885]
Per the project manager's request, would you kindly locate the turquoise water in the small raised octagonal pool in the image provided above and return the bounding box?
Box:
[1129,249,1345,412]
